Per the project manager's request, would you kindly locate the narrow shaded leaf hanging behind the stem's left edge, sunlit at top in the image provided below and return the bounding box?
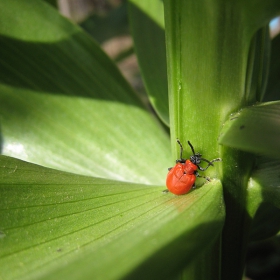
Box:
[129,0,169,125]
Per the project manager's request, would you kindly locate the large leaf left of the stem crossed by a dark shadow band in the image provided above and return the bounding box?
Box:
[0,0,171,184]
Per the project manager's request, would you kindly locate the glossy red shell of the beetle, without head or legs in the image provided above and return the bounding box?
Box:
[166,160,197,195]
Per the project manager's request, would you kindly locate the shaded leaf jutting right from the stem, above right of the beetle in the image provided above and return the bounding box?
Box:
[219,101,280,158]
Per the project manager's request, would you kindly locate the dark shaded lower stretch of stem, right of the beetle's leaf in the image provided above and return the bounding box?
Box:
[221,148,254,279]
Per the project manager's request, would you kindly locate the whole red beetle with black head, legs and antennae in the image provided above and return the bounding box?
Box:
[166,139,221,195]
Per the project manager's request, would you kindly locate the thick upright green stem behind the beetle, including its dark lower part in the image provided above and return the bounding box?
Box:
[165,0,262,280]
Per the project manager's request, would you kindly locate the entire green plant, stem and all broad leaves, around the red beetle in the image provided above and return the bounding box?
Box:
[0,0,280,280]
